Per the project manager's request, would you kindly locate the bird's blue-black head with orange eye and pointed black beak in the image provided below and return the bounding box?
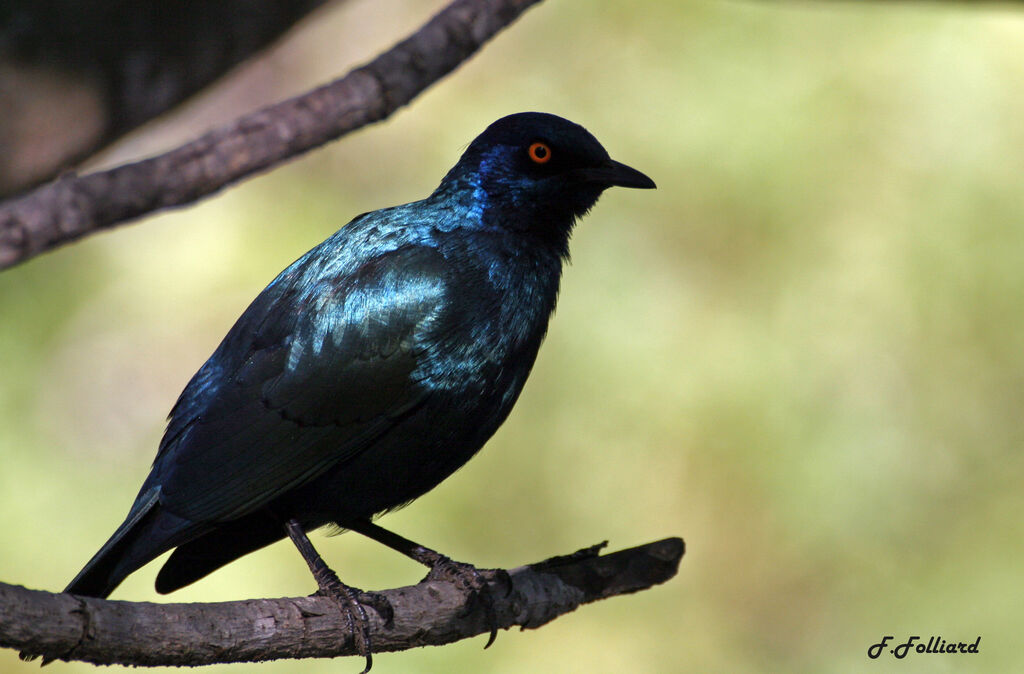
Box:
[434,113,654,250]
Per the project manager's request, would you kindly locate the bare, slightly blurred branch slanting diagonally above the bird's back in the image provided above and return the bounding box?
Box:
[0,0,540,269]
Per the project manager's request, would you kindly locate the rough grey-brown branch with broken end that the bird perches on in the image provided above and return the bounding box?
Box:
[6,538,684,666]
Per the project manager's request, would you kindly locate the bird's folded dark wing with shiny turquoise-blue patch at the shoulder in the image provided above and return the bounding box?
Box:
[150,246,446,521]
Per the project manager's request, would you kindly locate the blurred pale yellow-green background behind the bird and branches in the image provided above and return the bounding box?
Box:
[0,0,1024,674]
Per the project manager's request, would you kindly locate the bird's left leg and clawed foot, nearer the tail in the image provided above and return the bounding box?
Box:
[285,519,394,674]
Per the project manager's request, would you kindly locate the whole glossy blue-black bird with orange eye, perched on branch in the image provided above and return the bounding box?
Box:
[48,112,655,671]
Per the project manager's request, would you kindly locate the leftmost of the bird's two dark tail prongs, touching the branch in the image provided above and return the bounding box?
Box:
[65,489,196,598]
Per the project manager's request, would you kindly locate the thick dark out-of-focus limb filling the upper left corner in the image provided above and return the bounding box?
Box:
[0,0,326,199]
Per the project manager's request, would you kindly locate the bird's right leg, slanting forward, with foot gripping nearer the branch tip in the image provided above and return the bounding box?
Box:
[343,519,512,648]
